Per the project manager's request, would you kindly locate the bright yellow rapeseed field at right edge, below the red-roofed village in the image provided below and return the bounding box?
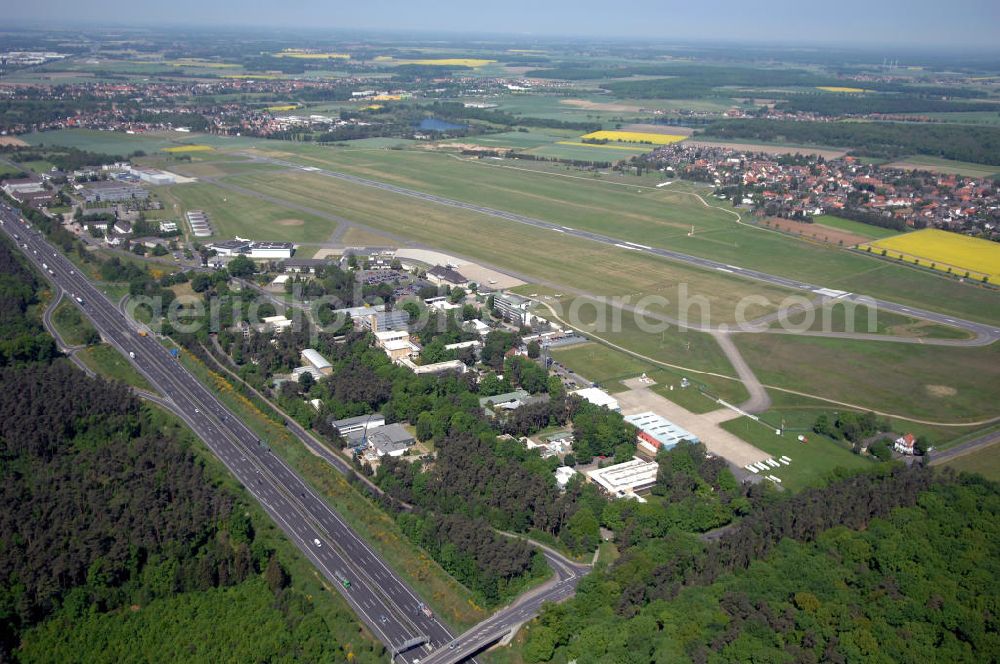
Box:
[858,228,1000,282]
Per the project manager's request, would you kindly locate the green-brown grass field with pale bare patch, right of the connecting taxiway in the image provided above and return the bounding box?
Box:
[734,334,1000,422]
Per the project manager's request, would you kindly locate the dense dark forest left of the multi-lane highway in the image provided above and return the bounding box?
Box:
[0,232,382,662]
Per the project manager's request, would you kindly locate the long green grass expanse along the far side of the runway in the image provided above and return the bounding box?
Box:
[225,145,1000,322]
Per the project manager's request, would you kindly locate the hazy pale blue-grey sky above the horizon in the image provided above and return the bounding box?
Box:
[3,0,1000,49]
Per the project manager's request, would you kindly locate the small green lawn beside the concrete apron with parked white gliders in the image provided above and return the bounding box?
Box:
[722,417,873,491]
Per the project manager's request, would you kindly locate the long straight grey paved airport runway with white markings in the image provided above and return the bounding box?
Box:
[240,155,1000,343]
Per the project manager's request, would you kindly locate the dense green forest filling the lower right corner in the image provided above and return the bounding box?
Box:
[522,469,1000,663]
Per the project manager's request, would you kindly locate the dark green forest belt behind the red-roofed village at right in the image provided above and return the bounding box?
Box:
[704,120,1000,165]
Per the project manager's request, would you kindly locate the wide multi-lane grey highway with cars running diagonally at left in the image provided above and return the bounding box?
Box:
[0,204,452,663]
